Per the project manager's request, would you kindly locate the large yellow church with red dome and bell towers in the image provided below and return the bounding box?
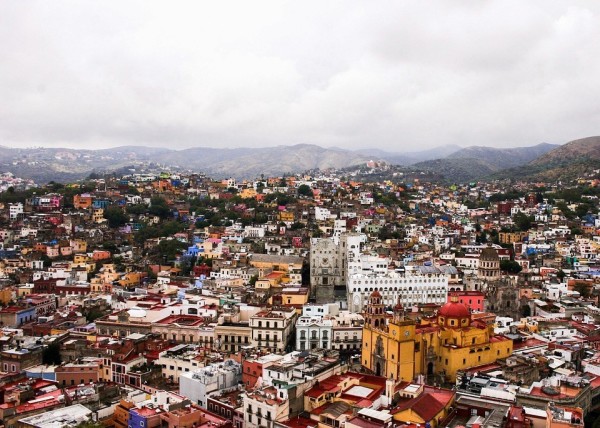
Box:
[361,290,513,383]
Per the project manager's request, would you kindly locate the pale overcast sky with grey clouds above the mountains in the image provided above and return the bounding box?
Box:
[0,0,600,152]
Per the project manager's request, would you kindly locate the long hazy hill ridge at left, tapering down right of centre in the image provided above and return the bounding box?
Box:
[0,144,371,183]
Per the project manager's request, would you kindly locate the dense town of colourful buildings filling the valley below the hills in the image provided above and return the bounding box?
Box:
[0,163,600,428]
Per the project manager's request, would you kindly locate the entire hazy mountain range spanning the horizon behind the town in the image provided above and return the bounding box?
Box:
[0,137,600,183]
